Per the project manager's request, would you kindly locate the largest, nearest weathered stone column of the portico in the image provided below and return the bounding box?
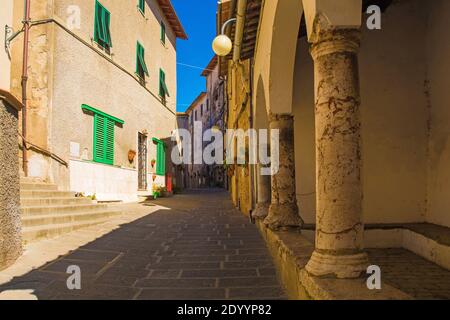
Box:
[306,29,368,278]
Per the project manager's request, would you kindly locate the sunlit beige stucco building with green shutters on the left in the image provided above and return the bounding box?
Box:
[11,0,186,201]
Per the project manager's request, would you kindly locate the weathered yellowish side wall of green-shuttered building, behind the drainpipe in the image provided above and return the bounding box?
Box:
[11,0,54,181]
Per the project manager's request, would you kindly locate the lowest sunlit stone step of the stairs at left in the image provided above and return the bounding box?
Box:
[22,210,121,228]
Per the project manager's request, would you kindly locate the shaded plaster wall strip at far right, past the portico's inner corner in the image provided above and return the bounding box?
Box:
[425,0,450,227]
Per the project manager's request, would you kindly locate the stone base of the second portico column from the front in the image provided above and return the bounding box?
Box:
[264,203,303,230]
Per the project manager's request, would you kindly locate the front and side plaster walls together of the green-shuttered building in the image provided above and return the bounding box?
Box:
[12,0,177,195]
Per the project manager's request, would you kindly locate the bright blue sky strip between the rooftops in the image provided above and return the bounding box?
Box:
[172,0,217,112]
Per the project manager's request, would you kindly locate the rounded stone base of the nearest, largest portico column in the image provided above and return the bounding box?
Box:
[305,251,369,279]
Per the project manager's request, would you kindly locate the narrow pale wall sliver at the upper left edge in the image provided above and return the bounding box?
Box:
[0,0,13,91]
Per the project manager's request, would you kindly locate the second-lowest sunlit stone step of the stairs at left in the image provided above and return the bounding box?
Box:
[21,203,108,216]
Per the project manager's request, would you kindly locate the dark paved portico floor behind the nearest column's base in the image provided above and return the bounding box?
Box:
[367,249,450,300]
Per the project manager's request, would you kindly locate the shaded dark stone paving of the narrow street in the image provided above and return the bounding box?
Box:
[0,190,285,300]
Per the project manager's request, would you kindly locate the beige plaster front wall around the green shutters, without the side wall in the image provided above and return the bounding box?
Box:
[52,0,176,189]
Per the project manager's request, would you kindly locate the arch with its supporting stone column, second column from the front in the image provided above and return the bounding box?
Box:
[254,0,303,229]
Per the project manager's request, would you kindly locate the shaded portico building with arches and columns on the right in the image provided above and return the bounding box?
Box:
[222,0,450,299]
